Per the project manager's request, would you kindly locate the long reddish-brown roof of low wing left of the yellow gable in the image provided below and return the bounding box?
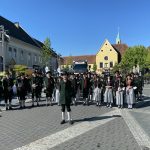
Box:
[63,55,96,64]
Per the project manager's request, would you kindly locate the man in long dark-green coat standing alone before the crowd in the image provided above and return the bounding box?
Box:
[59,72,73,124]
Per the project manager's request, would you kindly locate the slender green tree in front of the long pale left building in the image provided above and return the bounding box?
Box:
[41,38,52,65]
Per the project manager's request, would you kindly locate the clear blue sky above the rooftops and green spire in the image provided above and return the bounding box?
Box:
[0,0,150,56]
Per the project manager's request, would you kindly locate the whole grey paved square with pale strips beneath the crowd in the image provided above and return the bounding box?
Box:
[0,86,150,150]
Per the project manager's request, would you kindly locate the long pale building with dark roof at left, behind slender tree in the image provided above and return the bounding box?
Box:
[0,16,58,70]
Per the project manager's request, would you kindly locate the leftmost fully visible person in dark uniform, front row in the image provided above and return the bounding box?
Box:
[3,73,14,110]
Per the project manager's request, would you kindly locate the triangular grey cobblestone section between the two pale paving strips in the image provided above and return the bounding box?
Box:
[49,117,140,150]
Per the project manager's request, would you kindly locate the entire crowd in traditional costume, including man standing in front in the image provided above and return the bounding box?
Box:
[0,71,143,124]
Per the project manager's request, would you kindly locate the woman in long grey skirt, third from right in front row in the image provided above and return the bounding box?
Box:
[104,75,113,108]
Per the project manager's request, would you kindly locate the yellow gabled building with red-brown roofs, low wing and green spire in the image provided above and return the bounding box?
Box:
[61,33,128,74]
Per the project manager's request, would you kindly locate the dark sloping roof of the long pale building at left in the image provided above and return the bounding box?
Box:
[0,16,39,47]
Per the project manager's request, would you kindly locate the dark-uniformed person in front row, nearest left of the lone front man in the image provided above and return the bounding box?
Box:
[44,71,54,106]
